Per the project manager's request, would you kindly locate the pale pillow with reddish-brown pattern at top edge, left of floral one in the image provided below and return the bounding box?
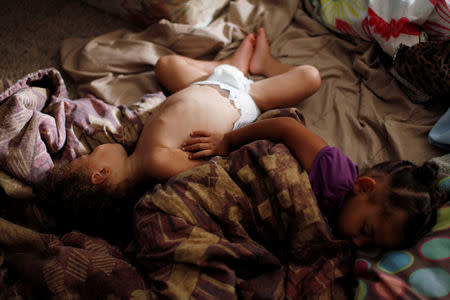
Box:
[84,0,230,28]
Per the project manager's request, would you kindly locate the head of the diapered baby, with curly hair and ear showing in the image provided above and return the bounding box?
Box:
[37,144,137,241]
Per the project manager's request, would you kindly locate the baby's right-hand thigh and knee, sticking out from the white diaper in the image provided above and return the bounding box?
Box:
[249,65,322,111]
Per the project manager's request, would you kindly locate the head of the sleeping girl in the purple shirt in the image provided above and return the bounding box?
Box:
[337,161,448,248]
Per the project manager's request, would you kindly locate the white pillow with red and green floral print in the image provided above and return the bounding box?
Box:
[303,0,450,56]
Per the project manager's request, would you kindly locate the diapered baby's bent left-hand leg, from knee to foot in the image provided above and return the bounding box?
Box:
[155,34,255,92]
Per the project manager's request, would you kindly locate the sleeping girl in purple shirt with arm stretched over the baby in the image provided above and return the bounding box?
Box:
[182,117,449,249]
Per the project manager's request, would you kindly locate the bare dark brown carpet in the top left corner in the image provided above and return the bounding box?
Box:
[0,0,137,98]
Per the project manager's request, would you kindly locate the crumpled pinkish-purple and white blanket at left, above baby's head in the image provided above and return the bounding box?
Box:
[0,69,164,196]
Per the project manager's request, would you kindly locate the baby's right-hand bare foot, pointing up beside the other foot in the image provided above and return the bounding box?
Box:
[249,28,273,75]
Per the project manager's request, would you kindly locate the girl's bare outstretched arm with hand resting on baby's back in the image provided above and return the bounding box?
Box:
[183,117,327,171]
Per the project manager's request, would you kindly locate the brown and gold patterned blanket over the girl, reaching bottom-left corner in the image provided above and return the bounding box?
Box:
[0,141,352,299]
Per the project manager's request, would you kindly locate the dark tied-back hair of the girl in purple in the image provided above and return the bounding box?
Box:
[361,160,449,246]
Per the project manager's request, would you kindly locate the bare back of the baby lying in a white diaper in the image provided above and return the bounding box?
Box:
[135,85,240,177]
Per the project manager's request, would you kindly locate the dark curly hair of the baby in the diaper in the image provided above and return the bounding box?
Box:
[34,164,142,241]
